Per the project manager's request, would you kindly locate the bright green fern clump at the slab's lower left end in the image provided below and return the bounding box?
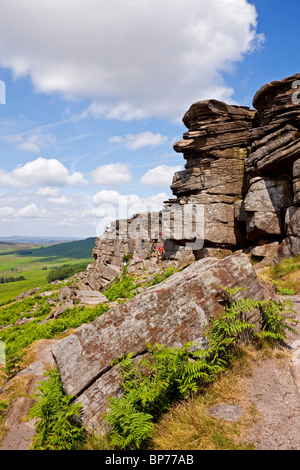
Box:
[29,368,85,450]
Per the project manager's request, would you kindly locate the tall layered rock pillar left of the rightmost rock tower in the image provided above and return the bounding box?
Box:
[171,100,255,248]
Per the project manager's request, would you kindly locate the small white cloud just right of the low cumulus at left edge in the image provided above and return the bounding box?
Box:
[92,163,131,186]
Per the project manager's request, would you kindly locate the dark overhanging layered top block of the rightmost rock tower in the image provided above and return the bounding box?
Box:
[245,74,300,176]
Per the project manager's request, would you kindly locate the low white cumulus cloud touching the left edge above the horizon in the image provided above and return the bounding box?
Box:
[0,157,87,188]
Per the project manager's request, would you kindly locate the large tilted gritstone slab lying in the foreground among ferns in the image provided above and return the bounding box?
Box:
[52,254,263,425]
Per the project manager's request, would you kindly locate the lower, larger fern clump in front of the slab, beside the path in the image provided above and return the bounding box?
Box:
[106,343,216,449]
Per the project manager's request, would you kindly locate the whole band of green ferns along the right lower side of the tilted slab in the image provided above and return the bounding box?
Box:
[95,286,295,449]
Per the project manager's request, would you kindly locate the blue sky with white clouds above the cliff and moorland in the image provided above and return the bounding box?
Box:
[0,0,300,238]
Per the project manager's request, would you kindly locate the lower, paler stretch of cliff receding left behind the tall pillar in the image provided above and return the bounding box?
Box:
[84,209,197,290]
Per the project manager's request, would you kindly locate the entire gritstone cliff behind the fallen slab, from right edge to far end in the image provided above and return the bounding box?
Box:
[84,74,300,290]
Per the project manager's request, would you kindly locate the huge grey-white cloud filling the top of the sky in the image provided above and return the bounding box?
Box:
[0,0,262,121]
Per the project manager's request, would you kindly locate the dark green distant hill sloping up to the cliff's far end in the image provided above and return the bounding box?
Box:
[17,237,95,259]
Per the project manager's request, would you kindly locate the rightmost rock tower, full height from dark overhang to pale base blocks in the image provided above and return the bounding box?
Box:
[244,74,300,254]
